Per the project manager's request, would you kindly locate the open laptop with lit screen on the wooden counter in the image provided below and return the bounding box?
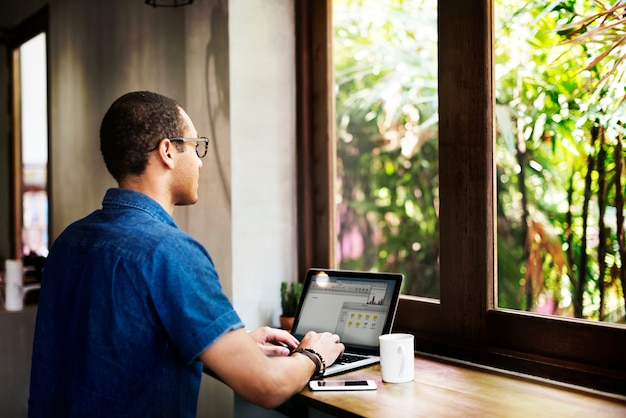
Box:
[291,268,403,376]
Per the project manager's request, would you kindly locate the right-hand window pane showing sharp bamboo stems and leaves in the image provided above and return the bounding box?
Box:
[494,0,626,323]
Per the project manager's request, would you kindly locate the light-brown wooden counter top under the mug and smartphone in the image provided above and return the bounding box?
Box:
[280,354,626,418]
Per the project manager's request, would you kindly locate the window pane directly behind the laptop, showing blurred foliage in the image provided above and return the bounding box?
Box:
[332,0,439,298]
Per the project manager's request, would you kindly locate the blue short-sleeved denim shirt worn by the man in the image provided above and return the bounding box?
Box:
[29,189,243,418]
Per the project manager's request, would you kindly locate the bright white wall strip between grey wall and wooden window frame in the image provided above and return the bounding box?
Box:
[229,0,297,328]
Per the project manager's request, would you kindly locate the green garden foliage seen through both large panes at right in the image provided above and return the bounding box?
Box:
[333,0,626,323]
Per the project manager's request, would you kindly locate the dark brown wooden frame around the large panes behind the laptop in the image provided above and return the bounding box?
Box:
[295,0,626,394]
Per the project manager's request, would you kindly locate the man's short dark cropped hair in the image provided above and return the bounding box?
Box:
[100,91,186,182]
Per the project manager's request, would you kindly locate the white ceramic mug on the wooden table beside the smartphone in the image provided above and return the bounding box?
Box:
[378,333,415,383]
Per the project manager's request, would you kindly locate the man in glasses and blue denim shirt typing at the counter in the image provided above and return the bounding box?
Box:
[29,92,344,418]
